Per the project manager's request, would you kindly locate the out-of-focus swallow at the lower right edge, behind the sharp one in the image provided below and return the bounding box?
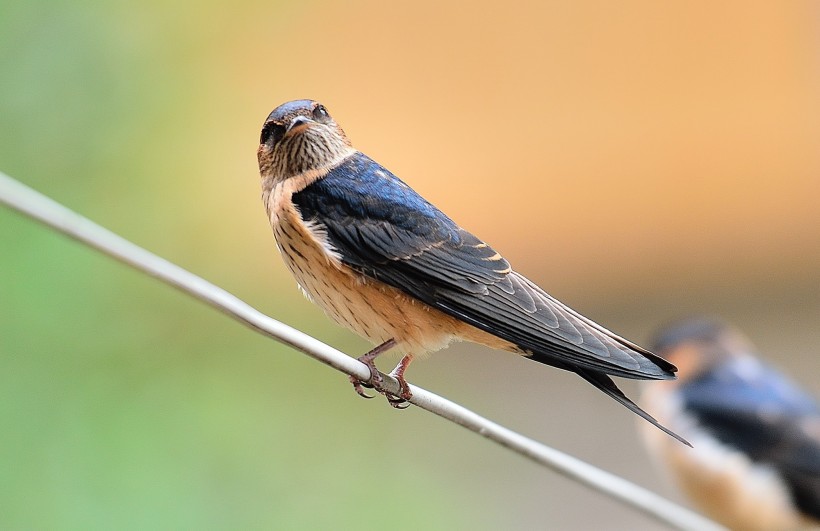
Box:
[641,318,820,530]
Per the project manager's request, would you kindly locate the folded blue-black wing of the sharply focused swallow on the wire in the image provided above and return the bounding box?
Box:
[293,153,674,380]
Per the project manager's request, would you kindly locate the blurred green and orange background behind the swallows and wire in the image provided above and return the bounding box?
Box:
[0,0,820,530]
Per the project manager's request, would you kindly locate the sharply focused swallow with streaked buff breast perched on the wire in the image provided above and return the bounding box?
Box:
[257,100,685,442]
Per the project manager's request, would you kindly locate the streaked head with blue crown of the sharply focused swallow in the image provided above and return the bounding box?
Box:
[257,100,353,182]
